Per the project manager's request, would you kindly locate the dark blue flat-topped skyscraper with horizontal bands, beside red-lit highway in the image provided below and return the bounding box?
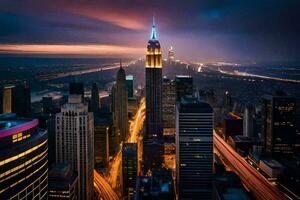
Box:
[176,96,213,199]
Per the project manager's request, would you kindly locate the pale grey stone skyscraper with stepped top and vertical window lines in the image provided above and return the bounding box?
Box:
[56,95,94,200]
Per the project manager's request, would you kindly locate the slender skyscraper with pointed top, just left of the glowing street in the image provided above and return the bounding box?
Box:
[113,63,129,141]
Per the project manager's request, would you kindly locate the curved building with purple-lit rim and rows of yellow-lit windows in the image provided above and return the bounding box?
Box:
[0,114,48,199]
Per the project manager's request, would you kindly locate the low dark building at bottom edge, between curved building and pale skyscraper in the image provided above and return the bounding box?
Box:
[48,163,78,200]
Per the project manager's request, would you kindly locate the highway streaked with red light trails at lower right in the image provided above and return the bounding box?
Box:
[214,132,288,200]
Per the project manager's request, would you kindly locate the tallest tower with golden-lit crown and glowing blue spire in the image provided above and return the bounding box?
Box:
[146,17,162,139]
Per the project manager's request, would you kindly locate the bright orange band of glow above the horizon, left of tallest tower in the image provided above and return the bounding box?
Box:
[0,44,144,56]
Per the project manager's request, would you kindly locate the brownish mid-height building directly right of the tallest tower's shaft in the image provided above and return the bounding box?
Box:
[162,77,176,135]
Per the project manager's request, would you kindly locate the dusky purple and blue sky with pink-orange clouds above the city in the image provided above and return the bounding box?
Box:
[0,0,300,62]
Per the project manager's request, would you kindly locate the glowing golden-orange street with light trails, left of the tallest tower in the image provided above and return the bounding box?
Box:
[94,98,146,200]
